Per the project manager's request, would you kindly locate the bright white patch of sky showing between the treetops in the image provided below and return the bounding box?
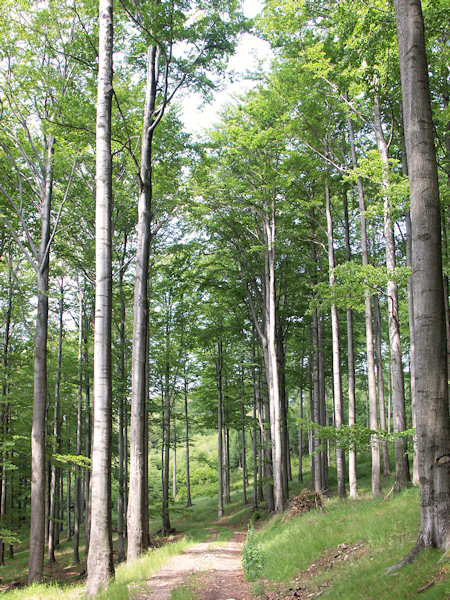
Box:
[180,0,270,135]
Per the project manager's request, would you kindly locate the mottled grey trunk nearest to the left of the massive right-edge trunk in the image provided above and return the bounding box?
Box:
[373,95,411,492]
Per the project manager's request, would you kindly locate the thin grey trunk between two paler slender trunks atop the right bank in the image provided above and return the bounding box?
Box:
[343,190,358,499]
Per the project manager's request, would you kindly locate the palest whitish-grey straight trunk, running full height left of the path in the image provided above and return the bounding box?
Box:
[86,0,114,598]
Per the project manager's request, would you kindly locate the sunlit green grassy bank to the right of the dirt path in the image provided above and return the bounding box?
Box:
[253,478,450,600]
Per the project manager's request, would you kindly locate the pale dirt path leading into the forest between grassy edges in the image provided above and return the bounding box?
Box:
[133,531,250,600]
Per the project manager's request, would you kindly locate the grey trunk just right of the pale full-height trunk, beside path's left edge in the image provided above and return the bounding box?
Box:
[127,46,158,562]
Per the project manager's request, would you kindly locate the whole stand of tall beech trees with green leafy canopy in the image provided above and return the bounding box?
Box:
[0,0,450,599]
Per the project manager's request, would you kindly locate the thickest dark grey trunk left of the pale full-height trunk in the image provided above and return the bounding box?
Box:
[28,136,54,584]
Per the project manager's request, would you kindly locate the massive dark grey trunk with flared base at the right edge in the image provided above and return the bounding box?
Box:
[394,0,450,566]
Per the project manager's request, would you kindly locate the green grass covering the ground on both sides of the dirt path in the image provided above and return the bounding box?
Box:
[0,446,450,600]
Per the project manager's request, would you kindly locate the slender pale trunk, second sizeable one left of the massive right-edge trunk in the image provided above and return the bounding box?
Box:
[347,111,381,498]
